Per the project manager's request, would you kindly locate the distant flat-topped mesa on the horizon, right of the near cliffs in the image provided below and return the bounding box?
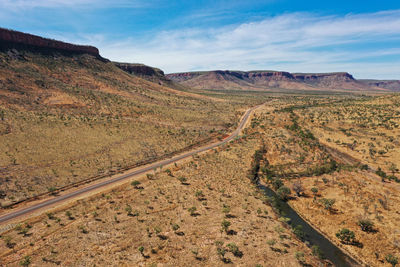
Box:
[166,70,400,92]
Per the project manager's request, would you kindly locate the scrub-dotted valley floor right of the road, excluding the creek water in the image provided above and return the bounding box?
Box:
[0,95,400,266]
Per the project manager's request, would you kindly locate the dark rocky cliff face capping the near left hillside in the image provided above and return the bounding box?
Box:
[0,28,103,59]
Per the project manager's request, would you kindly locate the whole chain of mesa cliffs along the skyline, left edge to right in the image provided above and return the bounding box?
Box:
[0,28,400,92]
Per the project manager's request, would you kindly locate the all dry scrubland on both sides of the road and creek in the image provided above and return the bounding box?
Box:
[0,58,400,266]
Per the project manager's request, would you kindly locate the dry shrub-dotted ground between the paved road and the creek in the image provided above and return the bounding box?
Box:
[0,133,318,266]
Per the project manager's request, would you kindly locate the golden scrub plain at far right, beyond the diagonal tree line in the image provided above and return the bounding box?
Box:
[299,95,400,173]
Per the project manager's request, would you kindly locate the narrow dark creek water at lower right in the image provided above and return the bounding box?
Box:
[258,184,360,267]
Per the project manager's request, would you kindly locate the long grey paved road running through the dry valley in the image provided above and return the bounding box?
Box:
[0,105,261,224]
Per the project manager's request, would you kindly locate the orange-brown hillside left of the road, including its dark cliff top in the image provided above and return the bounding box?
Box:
[0,30,260,206]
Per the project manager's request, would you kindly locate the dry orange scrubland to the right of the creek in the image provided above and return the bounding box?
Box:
[244,95,400,266]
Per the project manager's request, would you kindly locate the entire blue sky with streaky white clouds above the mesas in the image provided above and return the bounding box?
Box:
[0,0,400,79]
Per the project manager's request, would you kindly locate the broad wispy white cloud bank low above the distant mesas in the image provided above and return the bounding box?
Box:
[90,10,400,79]
